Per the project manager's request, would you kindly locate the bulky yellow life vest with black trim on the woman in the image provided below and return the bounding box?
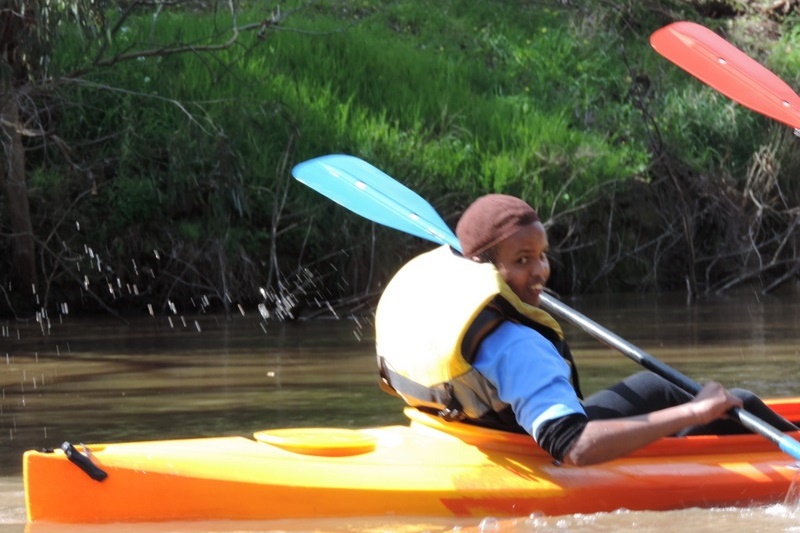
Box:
[375,246,580,426]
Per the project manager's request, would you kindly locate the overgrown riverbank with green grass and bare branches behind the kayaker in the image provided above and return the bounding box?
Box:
[0,0,800,318]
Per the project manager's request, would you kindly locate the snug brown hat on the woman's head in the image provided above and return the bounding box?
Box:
[456,194,539,258]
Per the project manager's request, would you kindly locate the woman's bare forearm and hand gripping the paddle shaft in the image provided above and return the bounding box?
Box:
[564,382,742,466]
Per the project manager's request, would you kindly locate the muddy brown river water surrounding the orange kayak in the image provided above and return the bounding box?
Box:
[0,290,800,533]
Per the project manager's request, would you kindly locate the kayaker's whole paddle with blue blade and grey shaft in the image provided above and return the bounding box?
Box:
[292,154,800,461]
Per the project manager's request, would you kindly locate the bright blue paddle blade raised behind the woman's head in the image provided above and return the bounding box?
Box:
[292,154,461,251]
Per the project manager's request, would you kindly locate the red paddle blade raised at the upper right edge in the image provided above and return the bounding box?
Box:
[650,22,800,129]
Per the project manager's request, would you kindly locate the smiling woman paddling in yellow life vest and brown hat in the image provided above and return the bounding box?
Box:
[376,194,797,466]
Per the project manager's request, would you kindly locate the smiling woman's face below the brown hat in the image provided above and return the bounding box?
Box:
[494,221,550,306]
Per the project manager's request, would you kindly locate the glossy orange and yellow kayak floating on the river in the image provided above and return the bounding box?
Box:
[23,398,800,523]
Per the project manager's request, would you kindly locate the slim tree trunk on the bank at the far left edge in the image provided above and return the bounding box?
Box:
[0,86,36,294]
